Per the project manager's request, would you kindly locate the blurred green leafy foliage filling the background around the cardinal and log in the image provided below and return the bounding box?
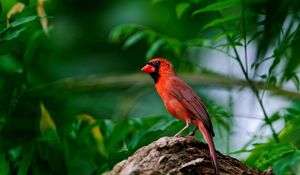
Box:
[0,0,300,175]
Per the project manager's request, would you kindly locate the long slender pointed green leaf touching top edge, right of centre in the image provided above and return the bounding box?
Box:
[192,0,240,16]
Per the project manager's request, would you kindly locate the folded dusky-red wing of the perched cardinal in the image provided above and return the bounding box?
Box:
[169,77,214,136]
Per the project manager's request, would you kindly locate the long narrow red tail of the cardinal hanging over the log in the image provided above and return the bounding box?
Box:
[197,120,220,175]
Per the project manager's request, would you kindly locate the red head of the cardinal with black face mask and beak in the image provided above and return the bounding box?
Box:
[141,58,175,83]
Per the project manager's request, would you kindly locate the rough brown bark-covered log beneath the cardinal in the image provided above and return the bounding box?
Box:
[103,136,273,175]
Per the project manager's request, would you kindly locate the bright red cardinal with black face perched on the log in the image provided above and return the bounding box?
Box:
[141,58,219,175]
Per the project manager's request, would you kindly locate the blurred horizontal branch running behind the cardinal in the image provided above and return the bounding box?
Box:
[24,73,300,100]
